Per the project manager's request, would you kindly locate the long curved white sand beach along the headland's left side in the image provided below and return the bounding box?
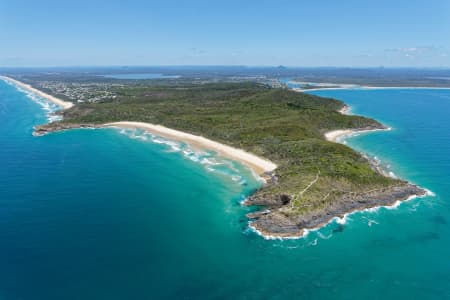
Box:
[104,121,277,175]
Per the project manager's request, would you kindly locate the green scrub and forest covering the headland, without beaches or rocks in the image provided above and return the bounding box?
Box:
[54,83,399,214]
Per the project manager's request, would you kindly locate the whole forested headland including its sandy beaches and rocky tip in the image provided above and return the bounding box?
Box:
[4,77,425,238]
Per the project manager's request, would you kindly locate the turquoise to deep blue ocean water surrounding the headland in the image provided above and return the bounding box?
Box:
[0,81,450,300]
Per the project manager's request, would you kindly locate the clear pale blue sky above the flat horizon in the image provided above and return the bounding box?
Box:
[0,0,450,67]
